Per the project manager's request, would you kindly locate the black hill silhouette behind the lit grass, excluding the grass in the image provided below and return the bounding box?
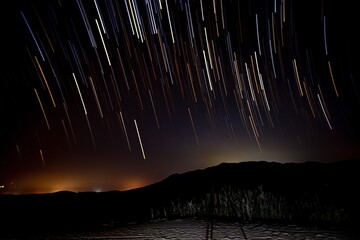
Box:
[0,160,360,236]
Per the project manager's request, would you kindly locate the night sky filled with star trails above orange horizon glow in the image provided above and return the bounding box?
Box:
[0,0,360,193]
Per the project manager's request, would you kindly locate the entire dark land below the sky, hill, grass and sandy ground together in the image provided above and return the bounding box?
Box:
[0,160,360,239]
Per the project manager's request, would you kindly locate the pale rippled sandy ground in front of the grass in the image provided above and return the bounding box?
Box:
[8,219,357,240]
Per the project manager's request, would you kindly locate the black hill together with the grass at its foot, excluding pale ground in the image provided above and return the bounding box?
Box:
[0,160,360,234]
